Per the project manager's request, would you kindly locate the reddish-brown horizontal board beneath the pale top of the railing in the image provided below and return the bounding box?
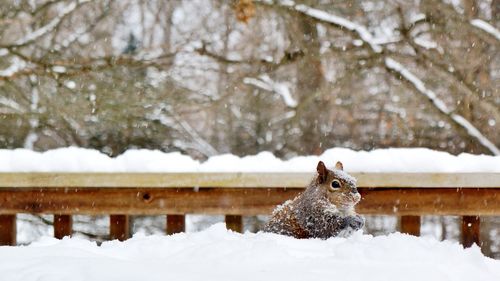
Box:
[0,188,500,216]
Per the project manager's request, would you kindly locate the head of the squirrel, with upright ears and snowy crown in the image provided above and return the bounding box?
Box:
[315,161,361,211]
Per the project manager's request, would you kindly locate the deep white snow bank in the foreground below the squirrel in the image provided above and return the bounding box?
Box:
[0,223,500,281]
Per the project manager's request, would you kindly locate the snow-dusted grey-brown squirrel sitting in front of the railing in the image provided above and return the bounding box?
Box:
[263,161,365,239]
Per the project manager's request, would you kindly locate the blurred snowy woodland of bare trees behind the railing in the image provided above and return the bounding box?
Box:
[0,0,500,158]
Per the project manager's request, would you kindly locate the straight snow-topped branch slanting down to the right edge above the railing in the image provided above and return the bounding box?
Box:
[385,58,500,155]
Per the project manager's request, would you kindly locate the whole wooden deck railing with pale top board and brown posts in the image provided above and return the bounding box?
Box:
[0,173,500,246]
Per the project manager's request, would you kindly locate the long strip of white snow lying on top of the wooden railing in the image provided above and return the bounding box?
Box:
[0,147,500,173]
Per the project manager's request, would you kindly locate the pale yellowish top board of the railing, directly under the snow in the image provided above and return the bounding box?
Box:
[0,172,500,188]
